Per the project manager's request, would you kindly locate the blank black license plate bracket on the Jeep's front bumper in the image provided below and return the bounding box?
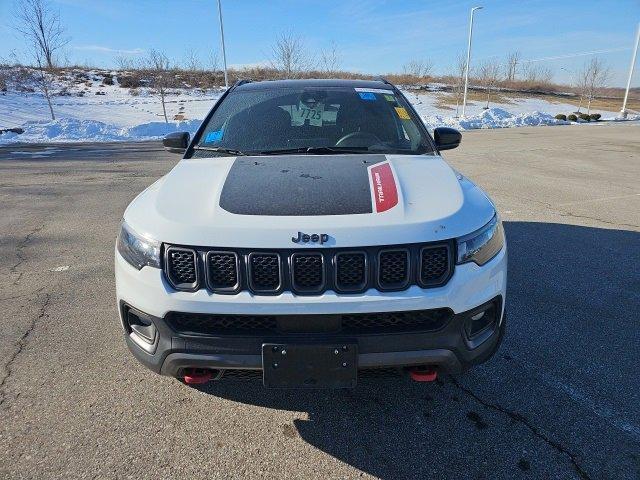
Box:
[262,343,358,388]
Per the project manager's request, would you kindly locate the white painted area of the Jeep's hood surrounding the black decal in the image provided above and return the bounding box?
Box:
[124,155,495,248]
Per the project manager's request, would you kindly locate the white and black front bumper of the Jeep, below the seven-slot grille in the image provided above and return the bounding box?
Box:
[116,249,507,377]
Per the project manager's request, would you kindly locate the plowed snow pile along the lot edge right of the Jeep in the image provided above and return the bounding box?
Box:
[423,107,571,130]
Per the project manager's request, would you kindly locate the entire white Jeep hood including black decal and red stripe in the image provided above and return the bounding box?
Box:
[125,155,494,248]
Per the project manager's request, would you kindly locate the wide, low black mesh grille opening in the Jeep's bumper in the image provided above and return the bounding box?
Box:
[165,308,453,335]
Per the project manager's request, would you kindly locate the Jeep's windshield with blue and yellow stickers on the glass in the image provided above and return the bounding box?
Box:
[196,86,433,155]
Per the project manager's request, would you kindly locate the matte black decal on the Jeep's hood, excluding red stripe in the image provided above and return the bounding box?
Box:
[220,155,386,216]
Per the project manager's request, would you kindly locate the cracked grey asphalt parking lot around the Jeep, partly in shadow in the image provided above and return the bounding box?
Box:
[0,125,640,479]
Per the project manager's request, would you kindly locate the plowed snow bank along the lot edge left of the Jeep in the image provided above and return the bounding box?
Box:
[0,118,201,144]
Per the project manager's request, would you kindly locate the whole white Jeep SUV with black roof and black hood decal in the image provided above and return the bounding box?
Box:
[115,80,507,388]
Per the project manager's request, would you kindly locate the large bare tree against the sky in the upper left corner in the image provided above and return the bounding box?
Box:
[15,0,69,69]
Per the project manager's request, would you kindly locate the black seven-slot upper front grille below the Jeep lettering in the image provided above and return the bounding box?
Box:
[164,243,454,295]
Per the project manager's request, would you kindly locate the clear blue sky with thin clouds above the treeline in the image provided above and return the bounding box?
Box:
[0,0,640,86]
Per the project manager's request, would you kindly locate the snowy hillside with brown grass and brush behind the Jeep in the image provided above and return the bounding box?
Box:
[0,67,636,143]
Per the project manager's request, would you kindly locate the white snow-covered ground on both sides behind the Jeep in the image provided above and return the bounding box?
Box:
[0,72,632,144]
